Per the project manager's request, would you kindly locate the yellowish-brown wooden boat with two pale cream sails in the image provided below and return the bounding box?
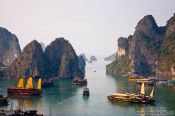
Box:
[108,83,155,104]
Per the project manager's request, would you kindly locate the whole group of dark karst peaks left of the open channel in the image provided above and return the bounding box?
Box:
[0,27,86,79]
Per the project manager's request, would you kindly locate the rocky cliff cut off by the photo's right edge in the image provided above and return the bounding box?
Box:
[159,14,175,78]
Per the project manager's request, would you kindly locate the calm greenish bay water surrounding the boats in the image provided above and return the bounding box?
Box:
[0,61,175,116]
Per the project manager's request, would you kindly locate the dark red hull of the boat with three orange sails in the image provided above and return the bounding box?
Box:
[7,88,41,96]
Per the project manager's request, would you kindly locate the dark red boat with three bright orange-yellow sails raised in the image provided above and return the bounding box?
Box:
[7,77,42,95]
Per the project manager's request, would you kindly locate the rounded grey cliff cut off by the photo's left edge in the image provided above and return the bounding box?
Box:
[0,27,21,66]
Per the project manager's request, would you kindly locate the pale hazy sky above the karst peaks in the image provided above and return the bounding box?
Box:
[0,0,175,56]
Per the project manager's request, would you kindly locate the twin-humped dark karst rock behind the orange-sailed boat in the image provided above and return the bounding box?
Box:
[3,38,85,79]
